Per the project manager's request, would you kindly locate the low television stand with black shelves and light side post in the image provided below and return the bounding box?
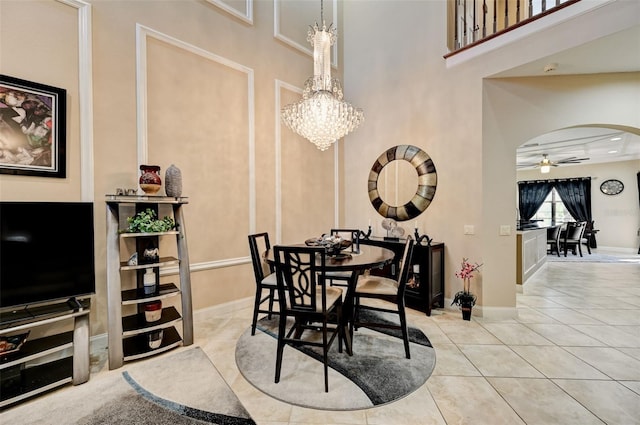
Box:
[0,299,91,409]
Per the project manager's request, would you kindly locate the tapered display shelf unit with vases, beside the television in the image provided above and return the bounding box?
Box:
[106,195,193,369]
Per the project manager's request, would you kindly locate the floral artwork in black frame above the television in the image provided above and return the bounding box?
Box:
[0,75,67,178]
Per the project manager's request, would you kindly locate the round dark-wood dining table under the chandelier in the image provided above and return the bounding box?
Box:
[262,244,395,355]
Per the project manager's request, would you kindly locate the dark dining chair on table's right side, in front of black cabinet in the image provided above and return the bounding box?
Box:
[353,239,414,359]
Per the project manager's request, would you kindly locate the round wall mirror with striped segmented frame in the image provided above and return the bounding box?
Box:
[369,145,438,221]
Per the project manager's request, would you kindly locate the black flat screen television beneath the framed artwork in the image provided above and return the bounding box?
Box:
[0,202,95,310]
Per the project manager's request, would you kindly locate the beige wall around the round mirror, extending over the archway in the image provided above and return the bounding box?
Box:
[344,1,640,315]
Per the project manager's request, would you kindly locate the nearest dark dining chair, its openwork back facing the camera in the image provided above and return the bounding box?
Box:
[273,245,346,392]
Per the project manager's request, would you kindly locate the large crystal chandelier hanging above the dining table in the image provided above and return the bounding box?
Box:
[282,1,364,151]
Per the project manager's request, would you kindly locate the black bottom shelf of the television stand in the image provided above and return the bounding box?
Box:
[0,357,73,407]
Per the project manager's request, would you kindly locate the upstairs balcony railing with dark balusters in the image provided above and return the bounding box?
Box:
[447,0,580,56]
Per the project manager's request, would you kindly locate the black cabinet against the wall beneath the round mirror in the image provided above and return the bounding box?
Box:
[360,237,444,316]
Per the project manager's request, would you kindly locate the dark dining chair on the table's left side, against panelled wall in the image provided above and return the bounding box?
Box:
[249,233,278,335]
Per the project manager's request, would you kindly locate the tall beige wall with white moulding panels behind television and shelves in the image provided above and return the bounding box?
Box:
[0,0,342,335]
